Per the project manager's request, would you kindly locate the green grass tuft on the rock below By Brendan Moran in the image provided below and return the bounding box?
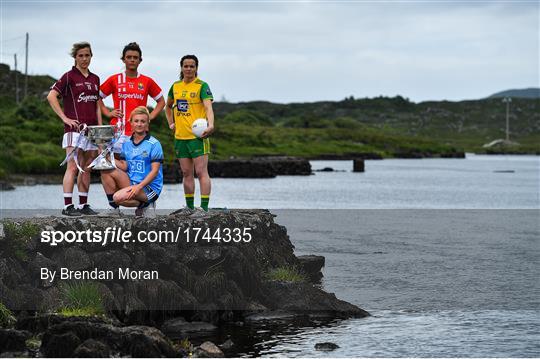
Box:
[58,282,105,317]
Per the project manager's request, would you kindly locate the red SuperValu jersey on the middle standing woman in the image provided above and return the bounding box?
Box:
[100,72,163,136]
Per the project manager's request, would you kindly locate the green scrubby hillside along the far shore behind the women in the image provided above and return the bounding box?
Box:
[0,64,540,180]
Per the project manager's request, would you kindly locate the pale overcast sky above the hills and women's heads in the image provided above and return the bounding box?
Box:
[0,0,540,103]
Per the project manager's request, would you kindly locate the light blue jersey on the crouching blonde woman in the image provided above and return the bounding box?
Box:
[121,135,163,194]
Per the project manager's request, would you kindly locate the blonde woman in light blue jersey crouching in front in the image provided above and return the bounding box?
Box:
[101,106,163,217]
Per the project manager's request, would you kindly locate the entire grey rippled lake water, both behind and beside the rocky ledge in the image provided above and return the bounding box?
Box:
[0,155,540,357]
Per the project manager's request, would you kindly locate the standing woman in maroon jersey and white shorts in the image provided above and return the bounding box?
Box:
[47,42,101,216]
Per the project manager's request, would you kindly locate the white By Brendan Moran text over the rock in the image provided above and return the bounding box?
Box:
[40,267,159,283]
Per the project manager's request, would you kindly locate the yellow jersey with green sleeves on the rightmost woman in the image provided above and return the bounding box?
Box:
[168,78,213,140]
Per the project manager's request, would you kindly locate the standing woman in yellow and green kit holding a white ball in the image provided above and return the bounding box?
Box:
[165,55,214,212]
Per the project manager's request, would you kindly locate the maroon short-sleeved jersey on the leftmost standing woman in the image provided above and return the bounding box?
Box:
[51,66,99,132]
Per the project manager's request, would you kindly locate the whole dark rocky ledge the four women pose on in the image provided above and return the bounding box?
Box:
[0,210,369,357]
